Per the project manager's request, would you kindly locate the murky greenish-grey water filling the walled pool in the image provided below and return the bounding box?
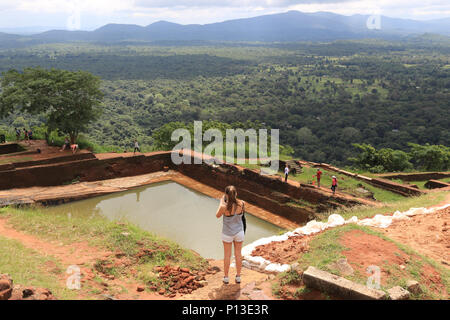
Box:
[47,182,281,259]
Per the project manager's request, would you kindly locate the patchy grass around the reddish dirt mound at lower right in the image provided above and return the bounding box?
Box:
[294,224,450,299]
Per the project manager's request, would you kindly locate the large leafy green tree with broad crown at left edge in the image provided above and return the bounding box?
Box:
[0,68,103,143]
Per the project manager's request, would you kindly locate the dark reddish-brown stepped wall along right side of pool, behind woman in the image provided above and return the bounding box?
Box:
[171,156,372,224]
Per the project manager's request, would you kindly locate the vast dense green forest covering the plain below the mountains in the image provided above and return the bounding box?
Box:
[0,37,450,165]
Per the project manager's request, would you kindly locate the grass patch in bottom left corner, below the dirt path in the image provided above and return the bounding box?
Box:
[0,236,76,299]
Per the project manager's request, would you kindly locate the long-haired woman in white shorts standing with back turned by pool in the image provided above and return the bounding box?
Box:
[216,186,246,284]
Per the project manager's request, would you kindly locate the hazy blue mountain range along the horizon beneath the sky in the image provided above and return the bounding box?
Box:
[0,11,450,45]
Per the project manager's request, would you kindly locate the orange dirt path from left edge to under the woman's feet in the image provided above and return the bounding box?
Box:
[0,218,275,300]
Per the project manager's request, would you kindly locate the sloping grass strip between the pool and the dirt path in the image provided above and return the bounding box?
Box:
[0,208,205,269]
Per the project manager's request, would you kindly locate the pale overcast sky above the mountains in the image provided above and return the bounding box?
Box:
[0,0,450,30]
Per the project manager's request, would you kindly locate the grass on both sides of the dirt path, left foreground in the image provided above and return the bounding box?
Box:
[0,208,207,298]
